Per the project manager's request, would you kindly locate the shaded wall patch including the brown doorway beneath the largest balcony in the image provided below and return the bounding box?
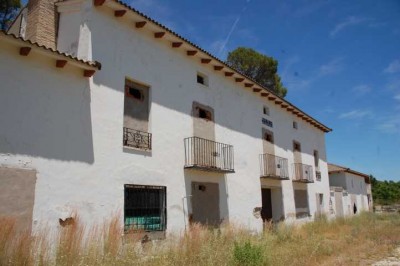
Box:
[184,169,229,226]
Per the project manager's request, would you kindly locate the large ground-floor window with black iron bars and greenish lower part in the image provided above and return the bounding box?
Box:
[124,185,167,231]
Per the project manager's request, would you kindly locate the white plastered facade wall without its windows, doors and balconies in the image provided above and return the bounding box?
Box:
[0,1,332,235]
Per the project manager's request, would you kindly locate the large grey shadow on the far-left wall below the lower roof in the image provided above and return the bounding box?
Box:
[0,69,94,164]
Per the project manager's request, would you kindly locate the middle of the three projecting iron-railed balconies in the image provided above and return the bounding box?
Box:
[260,153,289,180]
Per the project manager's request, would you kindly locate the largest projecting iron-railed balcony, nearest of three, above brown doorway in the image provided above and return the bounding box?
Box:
[184,137,235,173]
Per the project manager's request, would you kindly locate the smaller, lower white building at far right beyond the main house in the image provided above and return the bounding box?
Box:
[328,164,372,217]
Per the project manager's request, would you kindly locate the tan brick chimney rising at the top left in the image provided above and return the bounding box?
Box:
[25,0,58,49]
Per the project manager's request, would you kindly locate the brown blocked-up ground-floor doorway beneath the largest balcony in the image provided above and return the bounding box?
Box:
[191,182,220,226]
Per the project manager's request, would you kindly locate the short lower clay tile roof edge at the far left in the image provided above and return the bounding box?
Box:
[0,30,101,70]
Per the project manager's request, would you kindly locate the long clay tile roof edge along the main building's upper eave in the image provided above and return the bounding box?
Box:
[100,0,332,132]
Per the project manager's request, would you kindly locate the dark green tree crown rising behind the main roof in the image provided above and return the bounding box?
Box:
[227,47,287,97]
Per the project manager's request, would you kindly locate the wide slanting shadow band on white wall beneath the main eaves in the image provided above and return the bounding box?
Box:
[88,9,325,162]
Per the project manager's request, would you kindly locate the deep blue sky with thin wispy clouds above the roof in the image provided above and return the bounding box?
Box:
[126,0,400,181]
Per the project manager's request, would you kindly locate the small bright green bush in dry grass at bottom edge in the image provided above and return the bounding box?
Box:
[233,240,264,266]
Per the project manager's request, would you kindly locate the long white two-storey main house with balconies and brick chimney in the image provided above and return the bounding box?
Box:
[0,0,330,237]
